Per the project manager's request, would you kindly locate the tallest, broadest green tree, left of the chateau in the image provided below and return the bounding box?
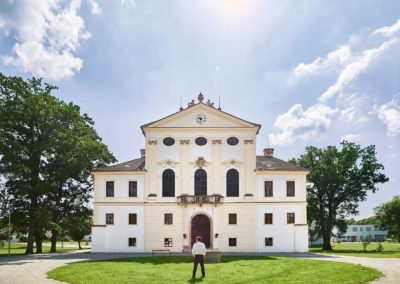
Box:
[0,73,115,254]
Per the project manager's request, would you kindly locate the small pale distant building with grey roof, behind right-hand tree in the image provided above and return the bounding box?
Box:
[339,224,388,242]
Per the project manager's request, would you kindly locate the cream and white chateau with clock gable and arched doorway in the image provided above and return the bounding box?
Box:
[92,94,308,252]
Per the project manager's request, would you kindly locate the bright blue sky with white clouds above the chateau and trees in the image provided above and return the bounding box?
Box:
[0,0,400,219]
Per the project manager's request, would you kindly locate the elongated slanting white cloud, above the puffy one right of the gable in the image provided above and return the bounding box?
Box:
[293,45,352,80]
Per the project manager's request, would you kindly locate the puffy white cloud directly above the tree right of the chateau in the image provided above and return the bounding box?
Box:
[269,104,337,144]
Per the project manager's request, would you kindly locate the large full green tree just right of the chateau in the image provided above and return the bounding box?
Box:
[290,141,389,250]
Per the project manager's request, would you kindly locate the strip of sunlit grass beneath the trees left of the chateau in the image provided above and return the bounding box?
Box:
[0,242,90,257]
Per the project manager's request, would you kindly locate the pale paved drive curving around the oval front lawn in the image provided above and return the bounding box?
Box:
[0,252,400,284]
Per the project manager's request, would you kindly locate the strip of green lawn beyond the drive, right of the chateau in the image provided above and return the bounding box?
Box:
[310,243,400,258]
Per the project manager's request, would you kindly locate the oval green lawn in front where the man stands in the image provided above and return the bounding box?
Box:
[48,256,381,284]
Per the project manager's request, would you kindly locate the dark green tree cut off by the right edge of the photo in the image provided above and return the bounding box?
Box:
[374,195,400,242]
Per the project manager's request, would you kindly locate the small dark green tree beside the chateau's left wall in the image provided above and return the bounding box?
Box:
[67,208,93,249]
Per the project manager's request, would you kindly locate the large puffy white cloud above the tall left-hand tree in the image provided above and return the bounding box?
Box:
[0,0,90,81]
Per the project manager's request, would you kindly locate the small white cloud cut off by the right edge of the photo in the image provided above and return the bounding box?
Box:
[376,99,400,136]
